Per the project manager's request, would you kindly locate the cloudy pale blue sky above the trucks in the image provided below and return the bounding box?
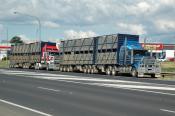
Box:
[0,0,175,43]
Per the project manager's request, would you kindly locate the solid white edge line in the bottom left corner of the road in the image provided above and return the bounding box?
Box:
[0,99,52,116]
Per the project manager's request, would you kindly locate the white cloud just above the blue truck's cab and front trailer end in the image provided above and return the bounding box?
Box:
[117,23,147,34]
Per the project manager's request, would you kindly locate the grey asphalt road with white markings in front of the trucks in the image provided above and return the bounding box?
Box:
[0,69,175,116]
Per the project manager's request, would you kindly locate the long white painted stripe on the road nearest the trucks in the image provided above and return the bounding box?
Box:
[0,70,175,89]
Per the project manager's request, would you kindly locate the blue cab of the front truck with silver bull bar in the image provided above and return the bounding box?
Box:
[119,38,161,77]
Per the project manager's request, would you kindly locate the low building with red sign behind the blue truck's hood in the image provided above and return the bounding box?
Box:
[141,43,175,61]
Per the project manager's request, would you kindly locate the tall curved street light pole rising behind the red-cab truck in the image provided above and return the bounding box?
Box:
[14,11,41,41]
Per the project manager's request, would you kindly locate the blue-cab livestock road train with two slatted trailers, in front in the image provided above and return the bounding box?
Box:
[59,34,161,77]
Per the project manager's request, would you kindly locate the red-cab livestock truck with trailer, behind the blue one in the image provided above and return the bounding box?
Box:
[10,41,59,70]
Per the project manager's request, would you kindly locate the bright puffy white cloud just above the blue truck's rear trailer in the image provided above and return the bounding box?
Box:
[64,30,97,39]
